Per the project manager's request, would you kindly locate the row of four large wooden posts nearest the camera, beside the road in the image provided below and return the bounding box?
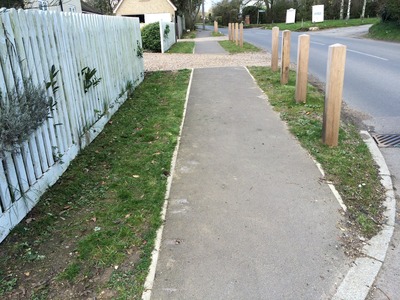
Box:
[271,27,346,147]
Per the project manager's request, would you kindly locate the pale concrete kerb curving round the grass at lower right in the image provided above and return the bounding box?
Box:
[332,130,396,300]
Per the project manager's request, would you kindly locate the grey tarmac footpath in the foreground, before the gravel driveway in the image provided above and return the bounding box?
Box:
[152,67,349,299]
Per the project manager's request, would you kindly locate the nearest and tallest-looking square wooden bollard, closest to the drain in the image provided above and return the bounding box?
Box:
[322,44,346,147]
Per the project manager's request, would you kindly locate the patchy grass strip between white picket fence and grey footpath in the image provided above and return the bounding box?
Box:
[0,70,190,299]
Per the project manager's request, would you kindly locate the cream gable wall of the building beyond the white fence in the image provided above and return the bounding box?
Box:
[115,0,175,19]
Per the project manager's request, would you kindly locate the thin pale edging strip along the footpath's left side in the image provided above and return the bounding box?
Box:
[142,69,194,300]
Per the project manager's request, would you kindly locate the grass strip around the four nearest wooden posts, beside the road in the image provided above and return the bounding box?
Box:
[249,67,384,237]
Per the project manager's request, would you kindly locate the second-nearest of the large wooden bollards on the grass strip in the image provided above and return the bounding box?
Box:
[295,34,310,102]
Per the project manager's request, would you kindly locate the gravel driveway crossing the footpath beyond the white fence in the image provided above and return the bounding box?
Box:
[143,52,271,72]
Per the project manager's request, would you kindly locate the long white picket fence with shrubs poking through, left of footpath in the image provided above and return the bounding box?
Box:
[0,9,144,242]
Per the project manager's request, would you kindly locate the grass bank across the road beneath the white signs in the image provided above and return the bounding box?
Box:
[264,18,379,31]
